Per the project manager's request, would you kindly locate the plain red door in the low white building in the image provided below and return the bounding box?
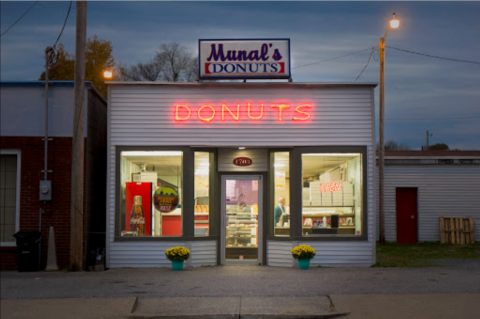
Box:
[396,188,418,244]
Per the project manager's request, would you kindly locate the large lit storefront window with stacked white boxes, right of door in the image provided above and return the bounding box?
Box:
[302,153,363,236]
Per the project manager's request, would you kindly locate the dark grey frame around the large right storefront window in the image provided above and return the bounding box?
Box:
[267,146,368,242]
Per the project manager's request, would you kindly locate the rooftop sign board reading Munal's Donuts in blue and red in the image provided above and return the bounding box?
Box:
[198,39,290,80]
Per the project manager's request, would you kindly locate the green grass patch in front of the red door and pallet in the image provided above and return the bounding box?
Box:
[376,242,480,267]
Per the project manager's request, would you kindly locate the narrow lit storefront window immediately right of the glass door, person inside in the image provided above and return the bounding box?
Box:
[273,152,290,236]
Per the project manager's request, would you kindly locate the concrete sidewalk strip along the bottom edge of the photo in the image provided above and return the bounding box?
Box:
[0,293,480,319]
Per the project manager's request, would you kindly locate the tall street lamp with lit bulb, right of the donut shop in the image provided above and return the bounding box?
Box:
[378,13,400,244]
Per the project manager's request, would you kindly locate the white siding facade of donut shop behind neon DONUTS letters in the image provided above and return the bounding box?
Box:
[107,83,375,267]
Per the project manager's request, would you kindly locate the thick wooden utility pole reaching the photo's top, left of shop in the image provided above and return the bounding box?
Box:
[70,1,87,271]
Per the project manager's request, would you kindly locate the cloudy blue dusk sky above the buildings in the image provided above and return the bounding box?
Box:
[0,1,480,150]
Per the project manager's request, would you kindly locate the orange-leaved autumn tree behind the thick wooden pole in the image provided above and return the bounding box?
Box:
[40,35,115,97]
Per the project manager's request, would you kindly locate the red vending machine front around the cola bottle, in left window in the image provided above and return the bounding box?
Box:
[125,182,152,236]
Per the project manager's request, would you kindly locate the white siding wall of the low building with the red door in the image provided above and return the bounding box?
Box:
[377,165,480,241]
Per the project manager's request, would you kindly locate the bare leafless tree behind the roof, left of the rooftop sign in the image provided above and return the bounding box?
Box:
[124,42,198,82]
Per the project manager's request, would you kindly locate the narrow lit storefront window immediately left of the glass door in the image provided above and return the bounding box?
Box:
[194,152,210,236]
